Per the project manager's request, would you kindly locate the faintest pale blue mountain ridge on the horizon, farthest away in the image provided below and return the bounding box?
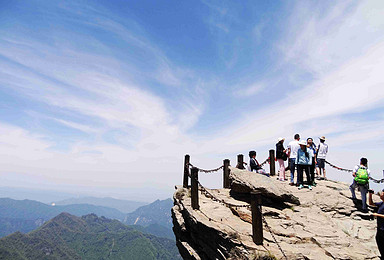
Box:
[54,197,148,213]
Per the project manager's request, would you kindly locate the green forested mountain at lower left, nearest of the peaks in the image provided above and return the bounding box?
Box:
[0,213,181,260]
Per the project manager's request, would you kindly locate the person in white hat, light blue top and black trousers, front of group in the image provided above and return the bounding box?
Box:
[296,141,312,190]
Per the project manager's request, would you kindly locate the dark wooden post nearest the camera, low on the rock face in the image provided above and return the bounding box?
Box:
[251,192,263,245]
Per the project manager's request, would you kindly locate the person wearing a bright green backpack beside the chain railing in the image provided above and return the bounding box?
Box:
[349,157,371,212]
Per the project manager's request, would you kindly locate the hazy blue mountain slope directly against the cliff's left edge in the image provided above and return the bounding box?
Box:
[124,199,175,239]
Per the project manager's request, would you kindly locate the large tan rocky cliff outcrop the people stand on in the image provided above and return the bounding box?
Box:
[172,168,380,259]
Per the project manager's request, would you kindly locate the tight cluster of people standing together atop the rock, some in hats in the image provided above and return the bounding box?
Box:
[276,134,328,190]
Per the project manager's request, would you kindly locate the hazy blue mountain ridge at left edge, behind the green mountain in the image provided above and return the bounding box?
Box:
[0,198,126,237]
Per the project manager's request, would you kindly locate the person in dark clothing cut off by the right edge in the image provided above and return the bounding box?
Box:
[368,190,384,259]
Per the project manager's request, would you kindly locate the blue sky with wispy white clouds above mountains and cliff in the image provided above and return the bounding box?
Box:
[0,0,384,201]
